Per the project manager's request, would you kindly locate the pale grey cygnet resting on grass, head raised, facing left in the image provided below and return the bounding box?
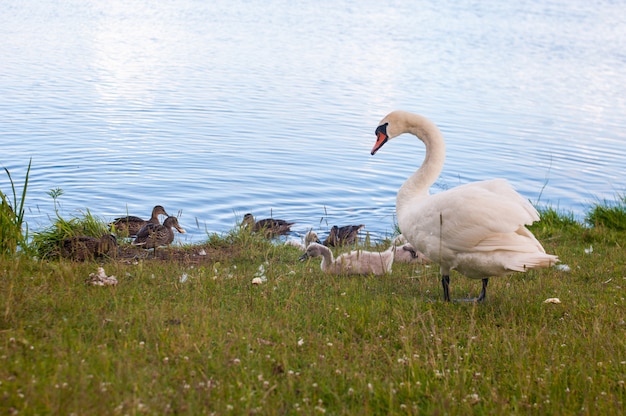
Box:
[300,243,395,276]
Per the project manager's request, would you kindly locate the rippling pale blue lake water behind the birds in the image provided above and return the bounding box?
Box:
[0,0,626,243]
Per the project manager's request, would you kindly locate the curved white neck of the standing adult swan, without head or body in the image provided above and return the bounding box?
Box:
[396,114,446,216]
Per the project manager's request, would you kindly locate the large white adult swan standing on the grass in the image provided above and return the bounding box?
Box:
[371,111,558,301]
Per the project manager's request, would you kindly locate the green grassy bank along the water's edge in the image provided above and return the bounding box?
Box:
[0,166,626,415]
